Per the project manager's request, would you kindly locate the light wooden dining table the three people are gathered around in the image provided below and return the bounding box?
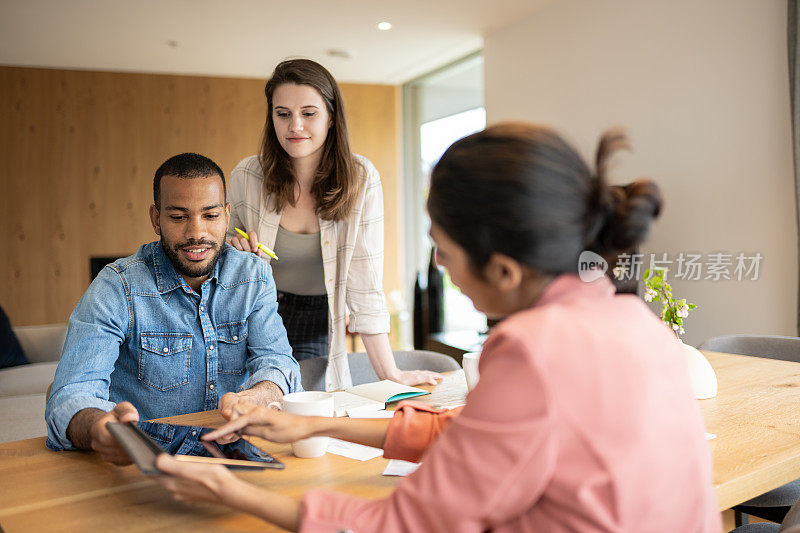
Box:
[0,352,800,533]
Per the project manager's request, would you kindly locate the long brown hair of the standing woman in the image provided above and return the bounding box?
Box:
[259,59,363,220]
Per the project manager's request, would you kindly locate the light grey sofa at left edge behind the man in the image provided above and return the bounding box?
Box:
[0,324,67,442]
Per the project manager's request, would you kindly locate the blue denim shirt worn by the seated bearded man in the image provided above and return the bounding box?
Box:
[45,241,303,450]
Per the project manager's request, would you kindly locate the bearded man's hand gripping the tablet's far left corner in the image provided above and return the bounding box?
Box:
[67,402,139,466]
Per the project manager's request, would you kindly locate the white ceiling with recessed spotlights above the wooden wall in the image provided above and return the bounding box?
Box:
[0,0,549,84]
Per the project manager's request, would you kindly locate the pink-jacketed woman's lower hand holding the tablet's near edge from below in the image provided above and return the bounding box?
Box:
[154,453,239,503]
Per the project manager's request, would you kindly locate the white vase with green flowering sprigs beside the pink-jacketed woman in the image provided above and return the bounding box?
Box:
[644,268,717,400]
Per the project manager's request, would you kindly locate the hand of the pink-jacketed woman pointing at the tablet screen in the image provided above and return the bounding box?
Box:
[203,402,319,443]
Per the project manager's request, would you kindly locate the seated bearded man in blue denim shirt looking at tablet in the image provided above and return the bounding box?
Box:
[45,154,302,464]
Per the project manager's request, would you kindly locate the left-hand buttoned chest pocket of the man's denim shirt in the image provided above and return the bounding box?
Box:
[139,333,192,390]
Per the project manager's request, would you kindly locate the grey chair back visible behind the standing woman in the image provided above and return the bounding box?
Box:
[300,350,461,390]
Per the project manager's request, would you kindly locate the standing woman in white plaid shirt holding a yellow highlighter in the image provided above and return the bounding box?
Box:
[228,59,440,390]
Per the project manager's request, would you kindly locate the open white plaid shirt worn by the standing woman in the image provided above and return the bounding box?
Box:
[228,155,389,391]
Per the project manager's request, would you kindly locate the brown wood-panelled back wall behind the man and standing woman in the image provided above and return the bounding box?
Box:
[0,67,402,325]
